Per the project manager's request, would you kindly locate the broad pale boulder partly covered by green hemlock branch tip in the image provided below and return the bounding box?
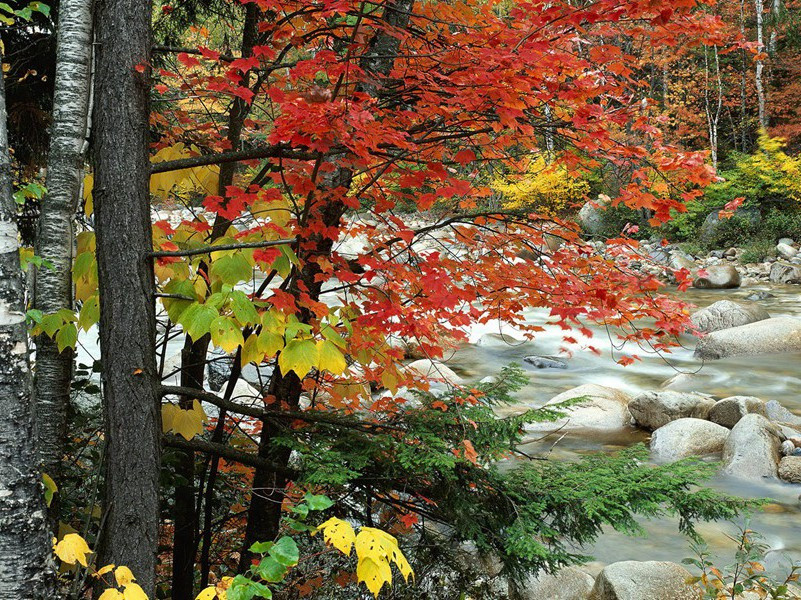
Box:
[526,383,631,432]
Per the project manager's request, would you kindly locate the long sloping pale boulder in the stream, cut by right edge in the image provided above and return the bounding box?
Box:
[695,317,801,360]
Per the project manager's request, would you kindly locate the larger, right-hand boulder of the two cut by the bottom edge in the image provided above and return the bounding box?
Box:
[589,560,698,600]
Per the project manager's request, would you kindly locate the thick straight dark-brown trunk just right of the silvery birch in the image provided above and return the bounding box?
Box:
[93,0,161,597]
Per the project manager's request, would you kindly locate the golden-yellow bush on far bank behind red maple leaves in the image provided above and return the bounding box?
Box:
[492,157,590,216]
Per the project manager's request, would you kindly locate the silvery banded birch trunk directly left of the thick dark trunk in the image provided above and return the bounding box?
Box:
[34,0,92,479]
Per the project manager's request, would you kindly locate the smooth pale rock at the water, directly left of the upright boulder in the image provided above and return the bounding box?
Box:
[651,418,729,462]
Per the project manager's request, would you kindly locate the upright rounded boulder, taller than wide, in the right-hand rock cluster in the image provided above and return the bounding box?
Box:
[723,414,784,480]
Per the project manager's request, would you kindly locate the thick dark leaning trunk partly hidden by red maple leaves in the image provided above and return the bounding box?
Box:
[239,0,414,572]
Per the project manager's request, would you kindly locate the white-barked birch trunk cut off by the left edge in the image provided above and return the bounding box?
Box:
[0,43,52,600]
